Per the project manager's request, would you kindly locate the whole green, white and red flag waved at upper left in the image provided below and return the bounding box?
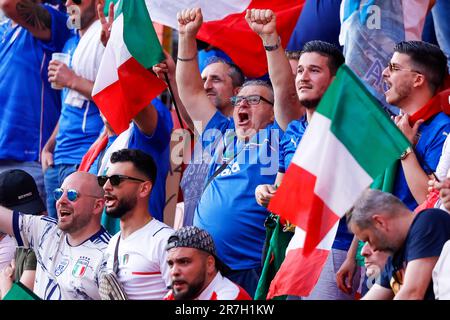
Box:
[92,0,166,135]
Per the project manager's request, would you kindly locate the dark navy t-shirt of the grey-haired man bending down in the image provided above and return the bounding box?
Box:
[380,209,450,300]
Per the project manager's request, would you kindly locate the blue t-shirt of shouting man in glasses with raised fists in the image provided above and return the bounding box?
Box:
[194,112,282,270]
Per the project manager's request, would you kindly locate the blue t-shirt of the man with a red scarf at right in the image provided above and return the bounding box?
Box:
[393,112,450,210]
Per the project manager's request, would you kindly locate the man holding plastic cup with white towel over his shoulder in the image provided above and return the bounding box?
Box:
[41,0,105,217]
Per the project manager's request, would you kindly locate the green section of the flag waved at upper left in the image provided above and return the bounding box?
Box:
[121,0,164,69]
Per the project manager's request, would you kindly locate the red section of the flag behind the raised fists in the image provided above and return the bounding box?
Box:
[197,0,305,78]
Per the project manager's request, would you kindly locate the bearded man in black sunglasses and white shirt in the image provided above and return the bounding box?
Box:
[97,149,173,300]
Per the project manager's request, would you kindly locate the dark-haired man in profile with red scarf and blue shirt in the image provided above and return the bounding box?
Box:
[383,41,450,210]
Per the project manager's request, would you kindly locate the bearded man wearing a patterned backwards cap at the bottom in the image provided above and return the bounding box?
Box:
[164,226,251,300]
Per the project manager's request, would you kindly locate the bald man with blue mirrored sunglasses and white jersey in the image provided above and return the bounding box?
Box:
[0,172,110,300]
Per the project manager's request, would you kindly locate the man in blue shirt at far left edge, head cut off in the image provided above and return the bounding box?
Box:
[0,0,70,209]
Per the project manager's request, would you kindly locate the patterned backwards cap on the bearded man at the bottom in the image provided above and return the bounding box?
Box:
[166,226,231,275]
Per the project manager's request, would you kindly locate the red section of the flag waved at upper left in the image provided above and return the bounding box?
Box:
[93,58,166,135]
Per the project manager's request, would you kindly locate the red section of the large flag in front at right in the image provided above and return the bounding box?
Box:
[269,162,339,255]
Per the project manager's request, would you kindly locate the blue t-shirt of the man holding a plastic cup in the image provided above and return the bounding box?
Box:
[54,35,103,164]
